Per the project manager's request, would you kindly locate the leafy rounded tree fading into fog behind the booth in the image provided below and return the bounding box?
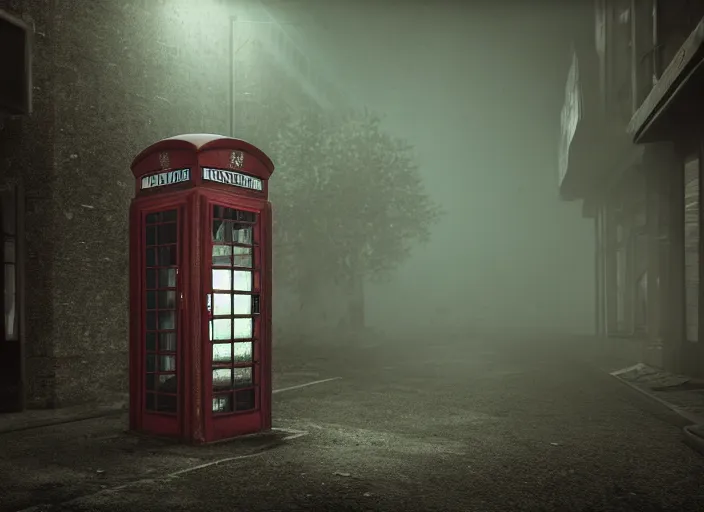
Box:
[272,111,440,332]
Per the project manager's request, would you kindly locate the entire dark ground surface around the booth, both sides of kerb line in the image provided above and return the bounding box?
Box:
[0,337,704,512]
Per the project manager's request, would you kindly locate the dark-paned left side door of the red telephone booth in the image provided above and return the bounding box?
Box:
[140,207,183,435]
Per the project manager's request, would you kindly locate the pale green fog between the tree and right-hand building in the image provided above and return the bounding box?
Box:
[266,0,594,342]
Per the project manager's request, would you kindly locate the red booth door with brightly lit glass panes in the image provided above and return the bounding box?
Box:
[209,204,266,439]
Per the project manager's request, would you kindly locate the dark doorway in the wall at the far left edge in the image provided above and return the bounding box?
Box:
[0,187,24,412]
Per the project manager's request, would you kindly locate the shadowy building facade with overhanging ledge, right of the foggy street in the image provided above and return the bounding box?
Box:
[559,0,704,376]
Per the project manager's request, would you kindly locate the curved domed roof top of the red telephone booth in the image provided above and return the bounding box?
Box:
[131,133,274,174]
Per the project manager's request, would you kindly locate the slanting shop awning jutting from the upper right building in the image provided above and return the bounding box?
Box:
[628,18,704,144]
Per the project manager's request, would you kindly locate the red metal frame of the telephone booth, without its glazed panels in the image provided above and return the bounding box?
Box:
[130,134,274,444]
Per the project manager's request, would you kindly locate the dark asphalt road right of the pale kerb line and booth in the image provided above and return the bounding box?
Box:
[11,342,704,512]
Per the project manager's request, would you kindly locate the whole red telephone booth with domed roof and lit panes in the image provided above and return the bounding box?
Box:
[130,134,274,443]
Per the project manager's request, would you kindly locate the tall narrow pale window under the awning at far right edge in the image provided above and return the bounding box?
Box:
[684,158,701,341]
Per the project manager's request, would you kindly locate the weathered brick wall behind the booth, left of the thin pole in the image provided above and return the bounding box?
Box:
[0,0,236,406]
